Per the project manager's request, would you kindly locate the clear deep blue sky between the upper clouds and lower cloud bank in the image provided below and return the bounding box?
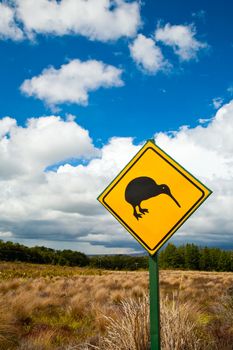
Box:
[0,1,233,142]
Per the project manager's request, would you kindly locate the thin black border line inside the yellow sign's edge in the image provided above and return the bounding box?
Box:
[103,146,205,250]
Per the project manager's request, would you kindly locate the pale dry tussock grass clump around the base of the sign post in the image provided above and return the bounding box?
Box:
[89,295,209,350]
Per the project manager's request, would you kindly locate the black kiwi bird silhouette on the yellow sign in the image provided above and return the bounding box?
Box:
[125,176,180,220]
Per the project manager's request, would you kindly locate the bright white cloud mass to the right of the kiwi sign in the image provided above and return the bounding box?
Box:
[156,101,233,247]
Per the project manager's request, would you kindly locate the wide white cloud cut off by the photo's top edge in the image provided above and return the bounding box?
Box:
[14,0,140,41]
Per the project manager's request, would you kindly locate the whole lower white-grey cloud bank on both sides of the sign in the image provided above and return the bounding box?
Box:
[0,101,233,253]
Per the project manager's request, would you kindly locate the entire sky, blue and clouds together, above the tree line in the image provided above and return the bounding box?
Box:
[0,0,233,253]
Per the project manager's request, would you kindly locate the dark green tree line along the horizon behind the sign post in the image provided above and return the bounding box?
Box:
[0,240,233,271]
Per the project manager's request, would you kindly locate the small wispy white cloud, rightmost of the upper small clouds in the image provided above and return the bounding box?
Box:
[155,23,207,61]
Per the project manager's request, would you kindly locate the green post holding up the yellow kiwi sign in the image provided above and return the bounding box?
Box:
[149,253,161,350]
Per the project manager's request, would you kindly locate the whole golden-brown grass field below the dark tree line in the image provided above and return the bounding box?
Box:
[0,263,233,350]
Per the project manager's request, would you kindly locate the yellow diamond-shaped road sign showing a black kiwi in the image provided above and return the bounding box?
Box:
[98,141,211,255]
